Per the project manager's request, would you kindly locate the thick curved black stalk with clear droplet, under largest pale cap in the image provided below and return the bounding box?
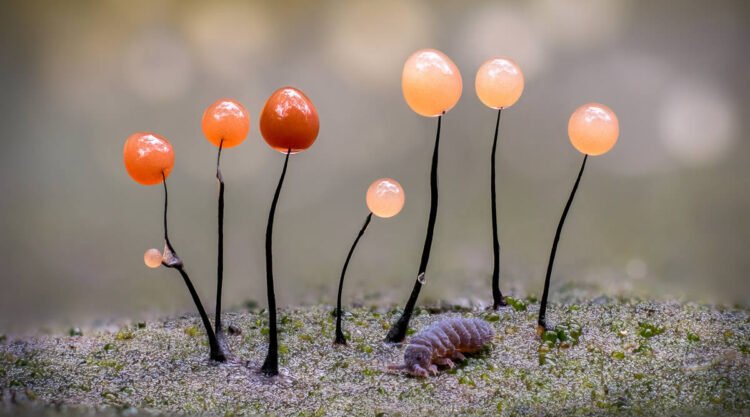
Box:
[385,112,445,343]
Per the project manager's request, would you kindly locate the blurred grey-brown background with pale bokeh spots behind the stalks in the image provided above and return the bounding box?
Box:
[0,0,750,332]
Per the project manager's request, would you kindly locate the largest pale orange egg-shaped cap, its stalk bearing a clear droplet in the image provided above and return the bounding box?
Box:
[401,49,463,117]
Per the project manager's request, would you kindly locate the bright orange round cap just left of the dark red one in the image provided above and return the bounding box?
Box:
[201,99,250,148]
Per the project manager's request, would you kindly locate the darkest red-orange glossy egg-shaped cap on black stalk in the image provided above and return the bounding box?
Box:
[260,87,320,153]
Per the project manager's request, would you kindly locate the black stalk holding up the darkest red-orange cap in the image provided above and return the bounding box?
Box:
[260,148,292,376]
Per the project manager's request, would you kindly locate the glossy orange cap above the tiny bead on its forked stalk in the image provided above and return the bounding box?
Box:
[123,132,174,185]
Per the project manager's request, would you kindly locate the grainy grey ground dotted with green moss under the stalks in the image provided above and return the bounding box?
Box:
[0,299,750,416]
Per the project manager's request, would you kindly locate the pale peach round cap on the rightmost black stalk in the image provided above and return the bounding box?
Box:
[568,103,620,156]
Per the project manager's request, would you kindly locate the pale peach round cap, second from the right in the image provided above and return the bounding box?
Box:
[474,58,523,109]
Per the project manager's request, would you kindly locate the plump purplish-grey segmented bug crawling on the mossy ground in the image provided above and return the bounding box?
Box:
[388,318,495,377]
